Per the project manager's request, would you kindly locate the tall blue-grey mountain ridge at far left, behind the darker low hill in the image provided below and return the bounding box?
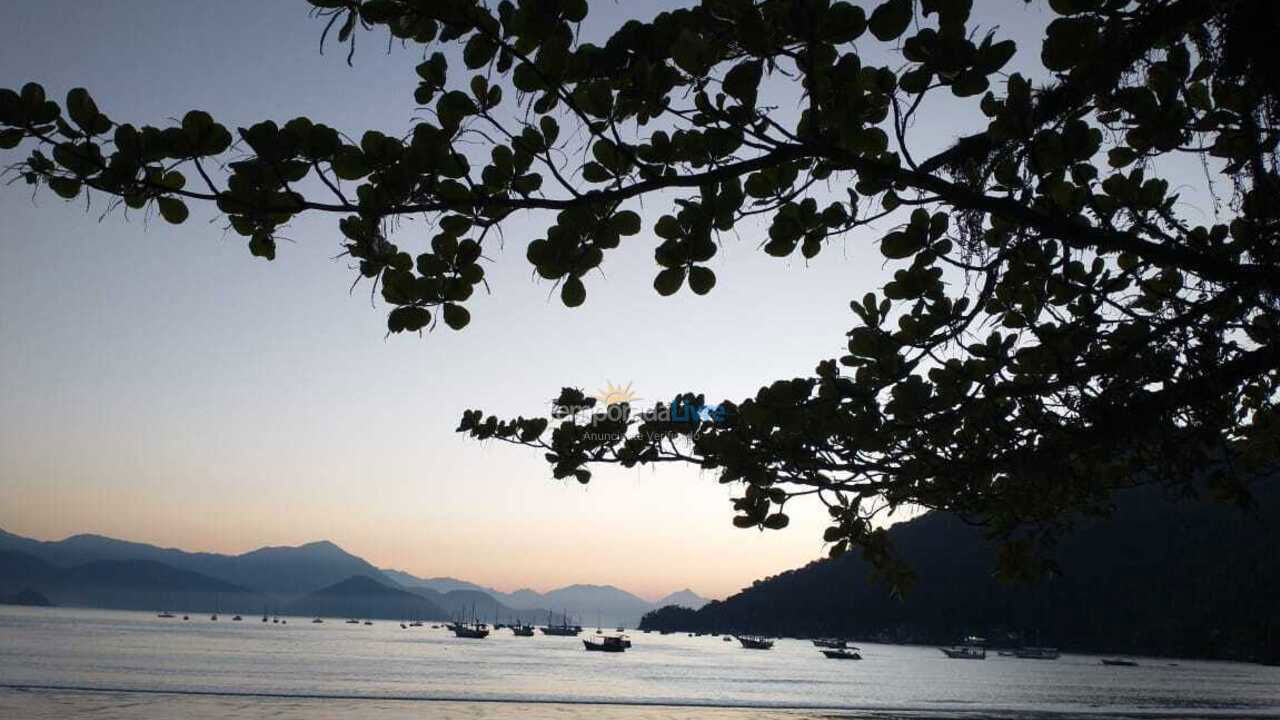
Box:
[0,530,385,597]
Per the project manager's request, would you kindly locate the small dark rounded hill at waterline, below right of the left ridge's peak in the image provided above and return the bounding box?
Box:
[283,575,449,620]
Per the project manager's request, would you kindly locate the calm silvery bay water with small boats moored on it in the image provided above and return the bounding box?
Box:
[0,606,1280,720]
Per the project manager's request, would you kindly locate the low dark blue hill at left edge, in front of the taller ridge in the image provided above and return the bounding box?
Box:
[0,551,264,611]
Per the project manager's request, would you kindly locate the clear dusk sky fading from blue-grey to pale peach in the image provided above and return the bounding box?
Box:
[0,0,1070,597]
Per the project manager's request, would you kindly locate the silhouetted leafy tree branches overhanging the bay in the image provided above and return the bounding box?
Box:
[0,0,1280,578]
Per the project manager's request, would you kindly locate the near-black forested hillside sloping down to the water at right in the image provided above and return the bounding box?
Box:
[641,479,1280,661]
